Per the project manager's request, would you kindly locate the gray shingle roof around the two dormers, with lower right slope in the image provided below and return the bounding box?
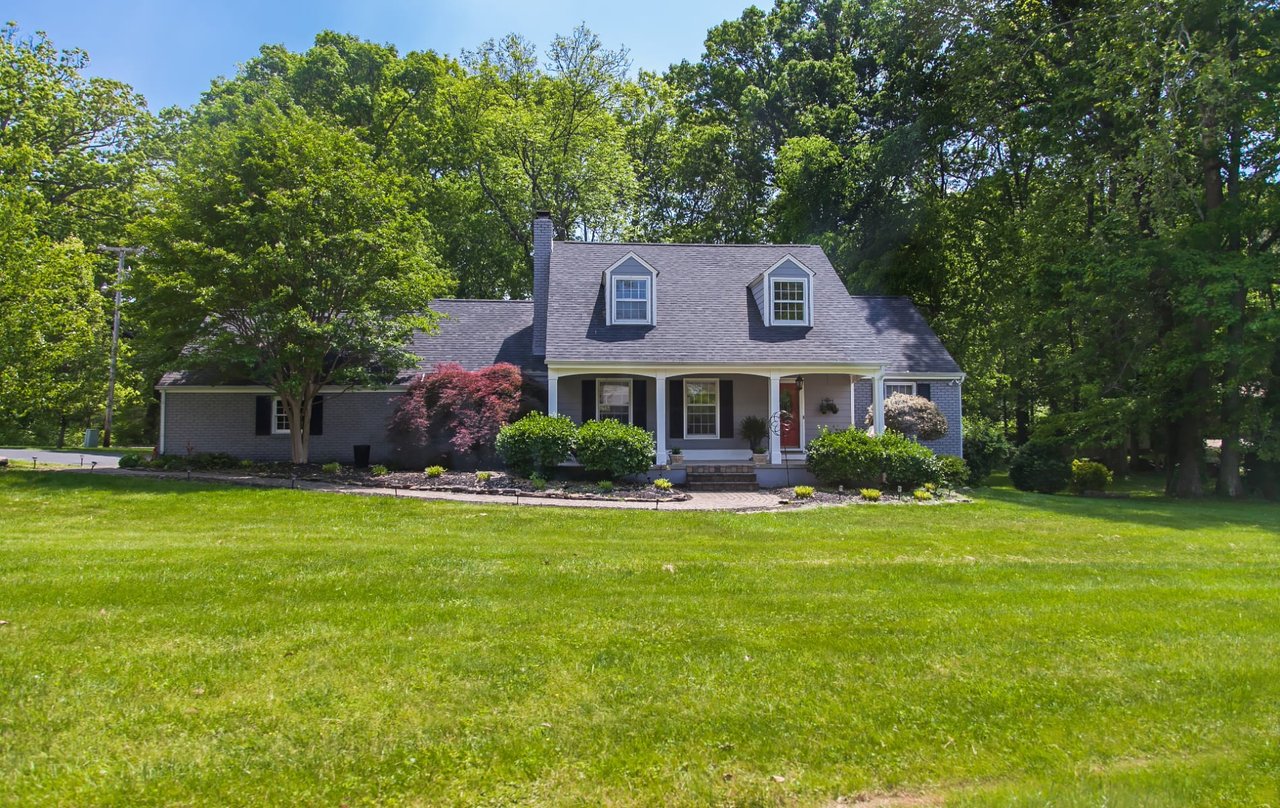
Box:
[547,242,960,373]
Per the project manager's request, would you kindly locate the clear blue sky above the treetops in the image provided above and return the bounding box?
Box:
[12,0,747,110]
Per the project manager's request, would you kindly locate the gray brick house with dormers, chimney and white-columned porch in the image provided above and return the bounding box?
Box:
[159,214,964,484]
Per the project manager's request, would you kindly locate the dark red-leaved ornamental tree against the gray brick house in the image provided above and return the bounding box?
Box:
[390,362,522,453]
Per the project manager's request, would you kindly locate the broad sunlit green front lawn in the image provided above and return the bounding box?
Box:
[0,471,1280,805]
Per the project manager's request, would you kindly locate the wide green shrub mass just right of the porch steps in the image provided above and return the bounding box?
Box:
[805,428,942,489]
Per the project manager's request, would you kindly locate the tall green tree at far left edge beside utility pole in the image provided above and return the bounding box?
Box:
[0,23,152,444]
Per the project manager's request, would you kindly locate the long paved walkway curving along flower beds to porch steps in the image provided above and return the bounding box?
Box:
[80,469,788,511]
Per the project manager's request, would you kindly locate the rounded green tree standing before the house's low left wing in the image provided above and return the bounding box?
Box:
[134,99,448,462]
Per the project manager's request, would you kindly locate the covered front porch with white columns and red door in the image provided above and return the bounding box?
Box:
[547,362,884,470]
